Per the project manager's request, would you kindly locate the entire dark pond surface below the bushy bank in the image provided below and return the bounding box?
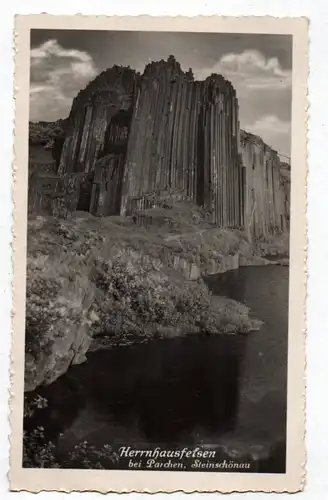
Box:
[28,266,289,472]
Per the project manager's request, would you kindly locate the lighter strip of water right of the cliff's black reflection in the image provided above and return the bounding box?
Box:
[208,266,289,450]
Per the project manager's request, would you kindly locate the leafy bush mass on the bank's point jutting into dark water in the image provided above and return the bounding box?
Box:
[89,256,248,335]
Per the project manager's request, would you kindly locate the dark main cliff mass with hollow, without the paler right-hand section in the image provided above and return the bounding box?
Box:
[59,56,244,227]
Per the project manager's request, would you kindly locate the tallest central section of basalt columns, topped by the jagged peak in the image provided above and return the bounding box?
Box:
[121,57,199,214]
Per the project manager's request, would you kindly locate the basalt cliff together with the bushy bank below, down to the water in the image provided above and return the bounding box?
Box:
[25,57,290,391]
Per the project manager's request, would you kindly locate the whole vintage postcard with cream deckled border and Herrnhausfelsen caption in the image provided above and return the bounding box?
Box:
[9,14,308,493]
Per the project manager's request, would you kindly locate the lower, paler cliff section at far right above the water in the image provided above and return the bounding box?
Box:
[241,131,289,241]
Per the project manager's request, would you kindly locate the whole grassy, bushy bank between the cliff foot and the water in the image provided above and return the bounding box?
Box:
[25,199,280,390]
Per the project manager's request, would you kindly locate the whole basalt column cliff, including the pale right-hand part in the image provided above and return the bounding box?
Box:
[29,56,289,238]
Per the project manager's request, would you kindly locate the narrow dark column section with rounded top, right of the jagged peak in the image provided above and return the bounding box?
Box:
[198,75,243,227]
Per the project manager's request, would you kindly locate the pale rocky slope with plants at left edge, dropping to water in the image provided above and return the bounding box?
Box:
[25,217,95,391]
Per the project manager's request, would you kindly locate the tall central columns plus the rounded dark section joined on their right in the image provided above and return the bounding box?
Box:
[121,57,243,227]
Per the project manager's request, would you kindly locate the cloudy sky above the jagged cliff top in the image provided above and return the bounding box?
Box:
[30,30,292,156]
